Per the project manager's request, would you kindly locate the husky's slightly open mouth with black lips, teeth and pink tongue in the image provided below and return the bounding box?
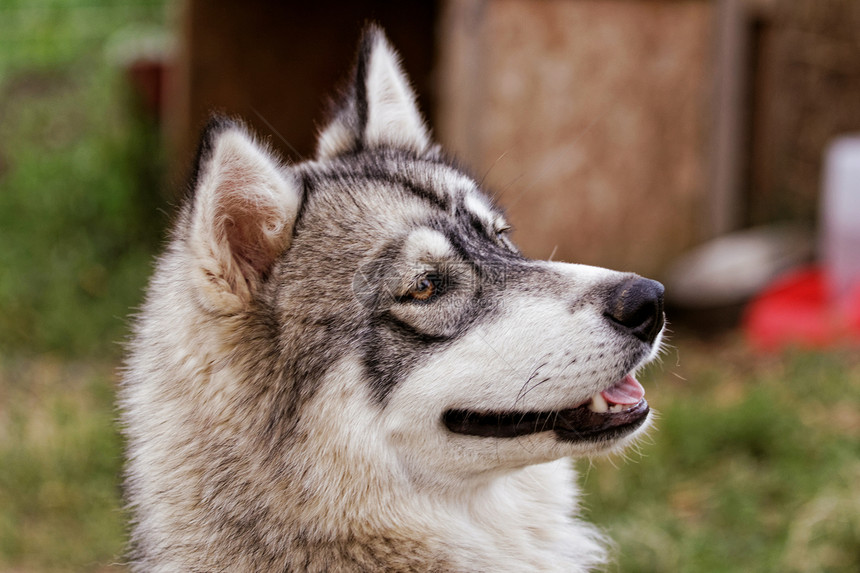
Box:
[443,374,650,442]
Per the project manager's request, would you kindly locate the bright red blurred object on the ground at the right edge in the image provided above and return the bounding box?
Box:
[743,267,860,351]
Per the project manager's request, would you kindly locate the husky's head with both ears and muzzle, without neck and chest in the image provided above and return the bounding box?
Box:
[179,28,664,478]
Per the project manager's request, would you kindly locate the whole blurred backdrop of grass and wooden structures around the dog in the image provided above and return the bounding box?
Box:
[0,0,860,572]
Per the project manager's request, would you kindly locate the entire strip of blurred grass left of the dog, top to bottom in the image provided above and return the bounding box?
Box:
[0,0,166,572]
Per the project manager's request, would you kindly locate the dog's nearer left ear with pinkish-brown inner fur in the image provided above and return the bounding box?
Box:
[188,117,301,312]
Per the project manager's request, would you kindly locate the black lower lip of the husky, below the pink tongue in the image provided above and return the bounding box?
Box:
[442,398,650,442]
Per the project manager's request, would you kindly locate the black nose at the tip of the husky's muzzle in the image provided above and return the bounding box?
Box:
[604,277,664,344]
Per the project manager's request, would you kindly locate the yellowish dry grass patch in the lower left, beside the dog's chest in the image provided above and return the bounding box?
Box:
[0,359,125,572]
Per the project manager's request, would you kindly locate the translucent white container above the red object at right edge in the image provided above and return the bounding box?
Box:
[821,135,860,306]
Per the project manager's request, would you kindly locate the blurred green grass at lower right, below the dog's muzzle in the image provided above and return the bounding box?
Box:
[581,336,860,572]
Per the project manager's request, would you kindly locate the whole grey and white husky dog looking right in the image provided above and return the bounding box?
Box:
[120,27,664,573]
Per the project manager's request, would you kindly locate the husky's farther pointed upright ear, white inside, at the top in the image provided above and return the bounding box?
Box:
[317,25,430,159]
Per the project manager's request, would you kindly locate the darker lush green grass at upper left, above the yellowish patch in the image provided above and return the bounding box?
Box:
[0,0,163,356]
